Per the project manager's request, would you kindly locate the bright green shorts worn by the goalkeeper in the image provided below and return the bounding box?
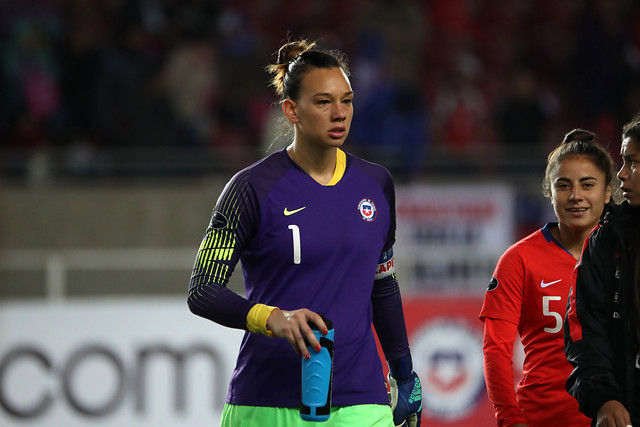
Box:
[220,403,394,427]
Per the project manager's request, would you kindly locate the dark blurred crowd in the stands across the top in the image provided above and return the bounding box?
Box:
[0,0,640,178]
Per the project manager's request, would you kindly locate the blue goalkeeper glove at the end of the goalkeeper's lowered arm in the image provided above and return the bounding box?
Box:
[388,371,422,427]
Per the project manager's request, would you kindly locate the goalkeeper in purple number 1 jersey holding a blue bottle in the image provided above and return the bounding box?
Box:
[188,40,422,427]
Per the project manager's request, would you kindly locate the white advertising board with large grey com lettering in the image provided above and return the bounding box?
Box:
[0,297,242,427]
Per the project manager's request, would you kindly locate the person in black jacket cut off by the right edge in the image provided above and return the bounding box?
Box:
[564,114,640,427]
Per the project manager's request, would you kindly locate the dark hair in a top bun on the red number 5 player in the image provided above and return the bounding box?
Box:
[542,129,619,203]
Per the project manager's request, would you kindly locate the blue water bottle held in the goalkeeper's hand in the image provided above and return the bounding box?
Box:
[300,317,334,421]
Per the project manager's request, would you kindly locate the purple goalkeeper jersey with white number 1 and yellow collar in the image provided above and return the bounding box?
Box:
[190,150,396,407]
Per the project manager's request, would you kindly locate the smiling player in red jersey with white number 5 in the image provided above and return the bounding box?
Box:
[480,129,615,427]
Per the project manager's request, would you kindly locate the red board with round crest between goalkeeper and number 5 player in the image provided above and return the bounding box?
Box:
[381,296,496,427]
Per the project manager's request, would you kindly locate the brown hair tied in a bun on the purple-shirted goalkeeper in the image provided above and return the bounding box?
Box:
[267,39,349,101]
